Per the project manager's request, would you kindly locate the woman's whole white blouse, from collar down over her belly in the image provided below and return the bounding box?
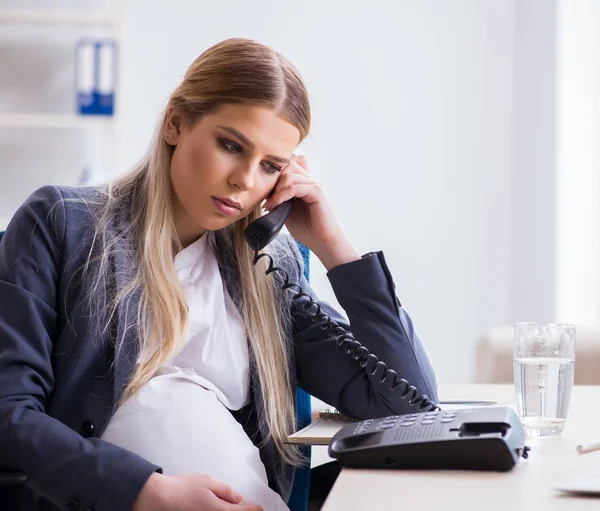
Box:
[102,233,288,511]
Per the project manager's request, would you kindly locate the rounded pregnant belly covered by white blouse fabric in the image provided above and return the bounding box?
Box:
[102,370,288,510]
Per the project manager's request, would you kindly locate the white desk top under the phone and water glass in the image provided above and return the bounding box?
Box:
[323,384,600,511]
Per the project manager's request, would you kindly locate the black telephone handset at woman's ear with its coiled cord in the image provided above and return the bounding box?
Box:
[244,199,439,411]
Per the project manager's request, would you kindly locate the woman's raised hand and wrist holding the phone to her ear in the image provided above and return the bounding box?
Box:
[264,155,354,266]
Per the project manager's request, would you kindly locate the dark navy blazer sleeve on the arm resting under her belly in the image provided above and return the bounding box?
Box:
[0,187,160,511]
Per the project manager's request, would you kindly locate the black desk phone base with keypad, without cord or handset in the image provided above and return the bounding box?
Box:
[329,406,529,471]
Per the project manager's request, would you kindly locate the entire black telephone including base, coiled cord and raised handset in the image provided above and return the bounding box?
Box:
[244,199,529,470]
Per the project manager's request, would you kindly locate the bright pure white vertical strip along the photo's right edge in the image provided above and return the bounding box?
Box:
[554,0,600,324]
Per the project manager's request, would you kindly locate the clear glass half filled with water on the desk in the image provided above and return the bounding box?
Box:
[513,323,575,437]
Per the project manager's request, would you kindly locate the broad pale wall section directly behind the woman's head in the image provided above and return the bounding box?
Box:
[120,0,514,381]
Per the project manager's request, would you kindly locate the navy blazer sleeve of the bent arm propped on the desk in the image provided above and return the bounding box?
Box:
[291,247,438,419]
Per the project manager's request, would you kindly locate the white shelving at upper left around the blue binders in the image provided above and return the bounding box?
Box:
[0,0,127,222]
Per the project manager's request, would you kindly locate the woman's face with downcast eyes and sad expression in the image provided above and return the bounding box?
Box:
[164,104,300,247]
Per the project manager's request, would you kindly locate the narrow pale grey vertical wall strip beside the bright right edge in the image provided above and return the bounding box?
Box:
[509,0,558,321]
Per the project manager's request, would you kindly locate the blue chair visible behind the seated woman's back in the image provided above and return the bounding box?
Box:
[0,231,312,511]
